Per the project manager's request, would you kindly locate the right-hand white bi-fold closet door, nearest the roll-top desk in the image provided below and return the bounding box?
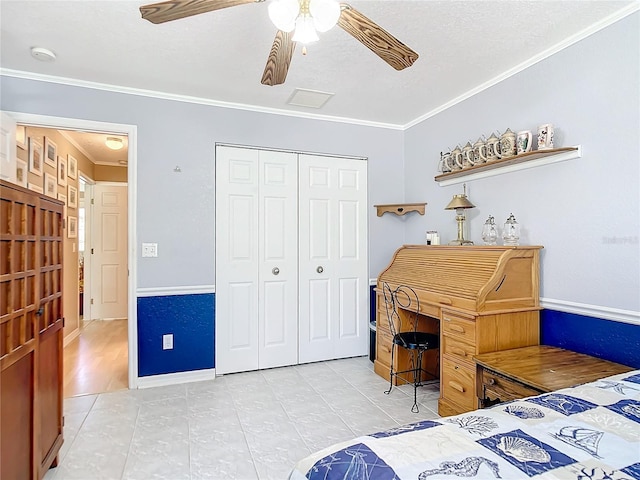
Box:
[298,155,369,363]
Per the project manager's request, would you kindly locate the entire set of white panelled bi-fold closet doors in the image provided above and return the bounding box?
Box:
[215,146,369,374]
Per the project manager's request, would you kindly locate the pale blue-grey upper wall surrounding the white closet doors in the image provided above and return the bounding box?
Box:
[0,76,404,288]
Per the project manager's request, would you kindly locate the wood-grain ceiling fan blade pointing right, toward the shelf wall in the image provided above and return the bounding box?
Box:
[338,3,418,70]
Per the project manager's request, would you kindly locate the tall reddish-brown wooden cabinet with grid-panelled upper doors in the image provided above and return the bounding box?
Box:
[0,181,63,480]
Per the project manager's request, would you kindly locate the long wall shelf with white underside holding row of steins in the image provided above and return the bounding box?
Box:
[435,145,582,187]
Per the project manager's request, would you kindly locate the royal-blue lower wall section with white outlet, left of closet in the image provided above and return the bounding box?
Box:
[138,294,215,377]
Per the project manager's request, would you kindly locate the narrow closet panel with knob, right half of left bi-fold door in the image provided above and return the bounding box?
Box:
[258,151,298,368]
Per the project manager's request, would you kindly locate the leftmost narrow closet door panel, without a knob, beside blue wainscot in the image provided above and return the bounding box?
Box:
[215,147,258,374]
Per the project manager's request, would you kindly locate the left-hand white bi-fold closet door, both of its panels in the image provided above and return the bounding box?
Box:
[216,146,298,374]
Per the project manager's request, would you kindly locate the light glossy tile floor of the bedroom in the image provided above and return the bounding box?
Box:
[45,357,439,480]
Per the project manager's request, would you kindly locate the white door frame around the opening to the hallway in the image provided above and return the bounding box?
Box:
[6,112,139,389]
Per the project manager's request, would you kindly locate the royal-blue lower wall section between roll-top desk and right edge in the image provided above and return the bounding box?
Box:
[540,310,640,368]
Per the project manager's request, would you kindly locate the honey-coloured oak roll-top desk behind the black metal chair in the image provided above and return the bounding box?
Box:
[374,245,542,416]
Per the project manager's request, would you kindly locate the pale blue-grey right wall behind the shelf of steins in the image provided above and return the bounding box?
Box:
[405,13,640,312]
